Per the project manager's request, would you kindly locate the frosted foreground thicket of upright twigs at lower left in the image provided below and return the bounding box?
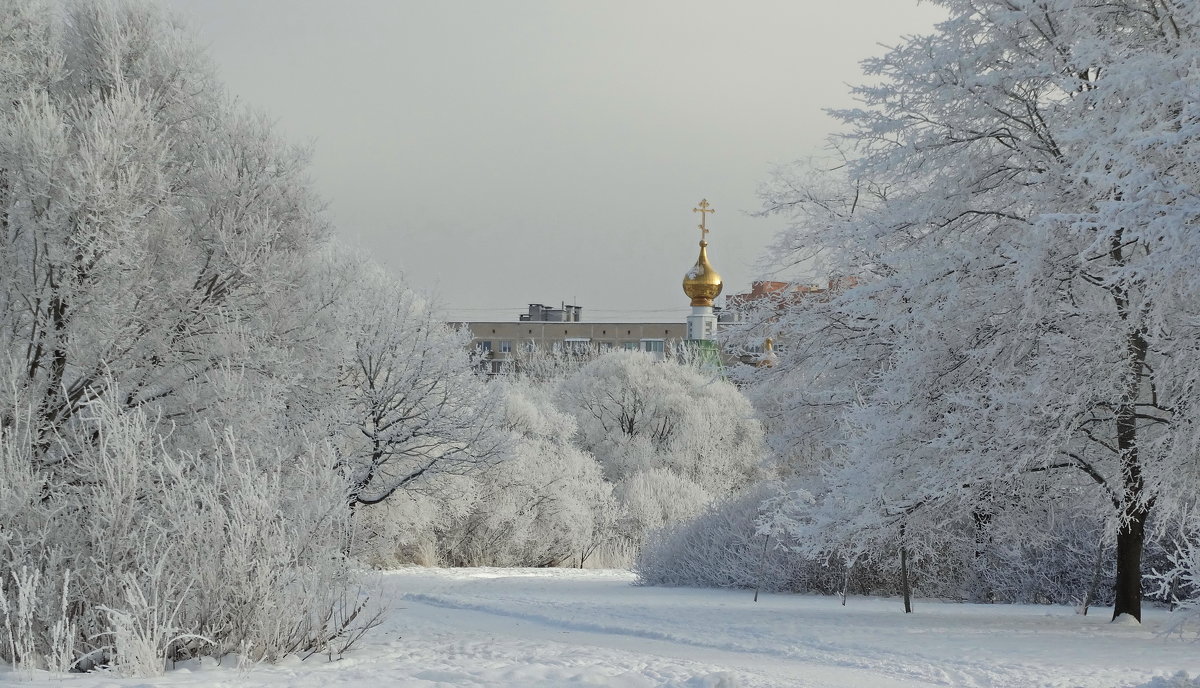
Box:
[0,397,364,675]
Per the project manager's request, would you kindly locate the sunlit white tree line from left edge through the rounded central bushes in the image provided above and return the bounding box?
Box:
[0,0,762,674]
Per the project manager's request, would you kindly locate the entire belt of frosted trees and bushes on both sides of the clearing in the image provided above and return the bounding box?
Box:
[0,0,1200,674]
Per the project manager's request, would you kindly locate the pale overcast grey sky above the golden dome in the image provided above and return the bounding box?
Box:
[168,0,940,321]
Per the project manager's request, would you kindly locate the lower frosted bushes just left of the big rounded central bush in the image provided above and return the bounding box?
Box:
[360,379,617,567]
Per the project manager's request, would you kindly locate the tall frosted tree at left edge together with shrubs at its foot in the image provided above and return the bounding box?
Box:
[0,0,374,672]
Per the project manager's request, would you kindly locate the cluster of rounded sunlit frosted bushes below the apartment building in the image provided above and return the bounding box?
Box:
[359,352,762,566]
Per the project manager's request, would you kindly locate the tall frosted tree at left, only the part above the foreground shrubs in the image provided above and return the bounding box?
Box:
[0,0,328,462]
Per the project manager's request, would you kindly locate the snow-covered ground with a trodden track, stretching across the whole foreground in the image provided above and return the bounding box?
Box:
[0,569,1200,688]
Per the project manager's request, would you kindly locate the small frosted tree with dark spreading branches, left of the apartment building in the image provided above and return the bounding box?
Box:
[341,268,505,504]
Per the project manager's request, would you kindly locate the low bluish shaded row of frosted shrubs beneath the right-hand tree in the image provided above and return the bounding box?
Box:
[634,473,1132,605]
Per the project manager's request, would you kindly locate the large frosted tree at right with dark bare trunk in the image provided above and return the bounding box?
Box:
[748,0,1200,617]
